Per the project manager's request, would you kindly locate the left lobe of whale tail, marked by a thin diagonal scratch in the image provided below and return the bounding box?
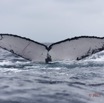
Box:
[0,34,47,62]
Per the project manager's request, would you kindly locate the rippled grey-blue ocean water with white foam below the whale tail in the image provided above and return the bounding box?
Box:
[0,49,104,103]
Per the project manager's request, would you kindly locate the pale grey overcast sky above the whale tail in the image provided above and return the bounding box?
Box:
[0,0,104,42]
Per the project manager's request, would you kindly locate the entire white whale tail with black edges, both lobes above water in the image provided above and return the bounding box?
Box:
[0,34,104,63]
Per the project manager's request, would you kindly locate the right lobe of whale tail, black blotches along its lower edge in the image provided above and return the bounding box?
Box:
[49,36,104,61]
